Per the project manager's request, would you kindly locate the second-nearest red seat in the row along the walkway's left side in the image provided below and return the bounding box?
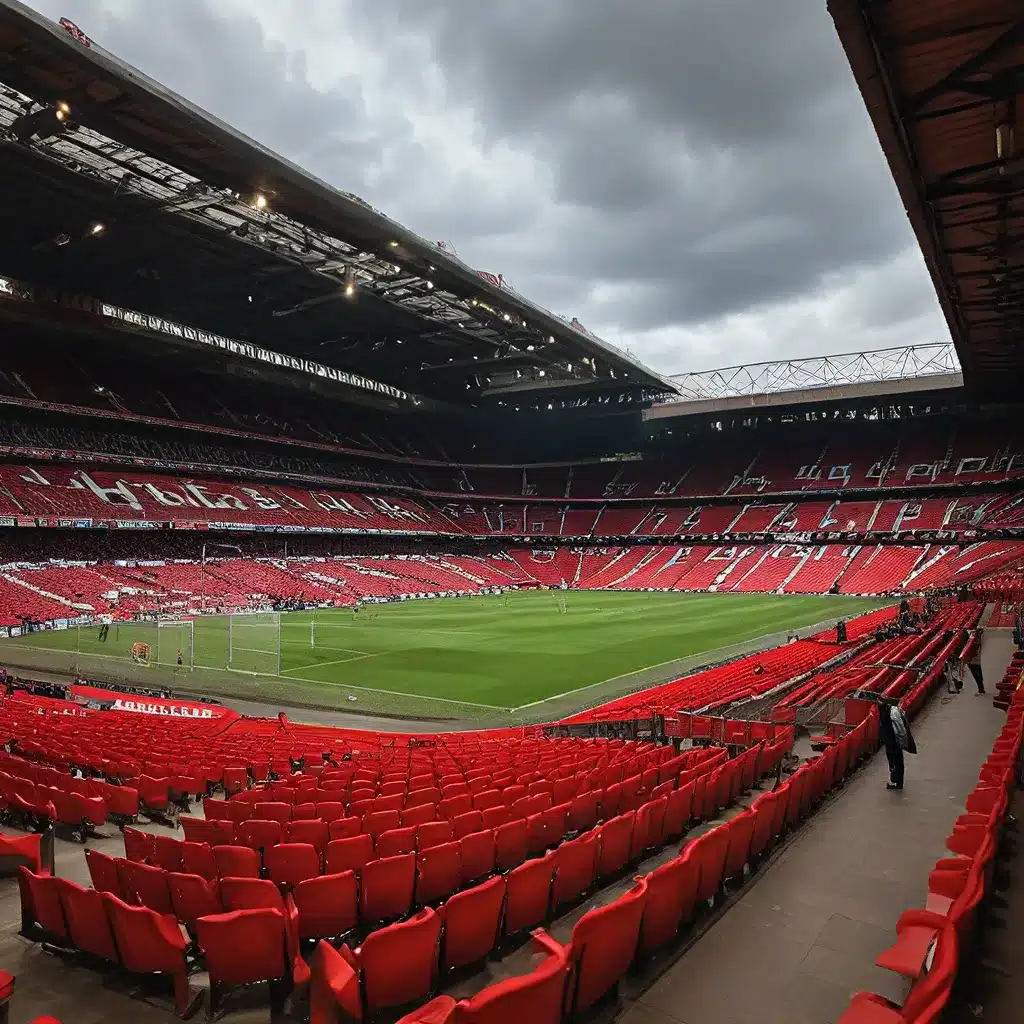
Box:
[569,879,647,1016]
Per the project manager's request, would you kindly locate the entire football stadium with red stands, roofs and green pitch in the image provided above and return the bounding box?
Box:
[0,0,1024,1024]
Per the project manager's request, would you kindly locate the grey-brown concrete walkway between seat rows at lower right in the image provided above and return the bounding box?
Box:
[620,631,1011,1024]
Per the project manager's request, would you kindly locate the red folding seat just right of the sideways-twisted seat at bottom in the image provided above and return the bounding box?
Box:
[335,907,441,1015]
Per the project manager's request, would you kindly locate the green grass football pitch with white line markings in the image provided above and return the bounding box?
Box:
[0,591,888,718]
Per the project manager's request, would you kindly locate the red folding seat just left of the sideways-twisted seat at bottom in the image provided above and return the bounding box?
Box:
[196,909,309,1018]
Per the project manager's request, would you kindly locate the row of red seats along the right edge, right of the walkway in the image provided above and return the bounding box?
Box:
[840,659,1024,1024]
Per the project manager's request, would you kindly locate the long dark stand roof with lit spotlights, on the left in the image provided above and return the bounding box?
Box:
[0,0,674,401]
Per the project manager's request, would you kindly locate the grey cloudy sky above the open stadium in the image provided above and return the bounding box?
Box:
[24,0,948,373]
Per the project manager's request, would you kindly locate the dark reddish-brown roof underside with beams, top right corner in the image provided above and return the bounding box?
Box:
[828,0,1024,393]
